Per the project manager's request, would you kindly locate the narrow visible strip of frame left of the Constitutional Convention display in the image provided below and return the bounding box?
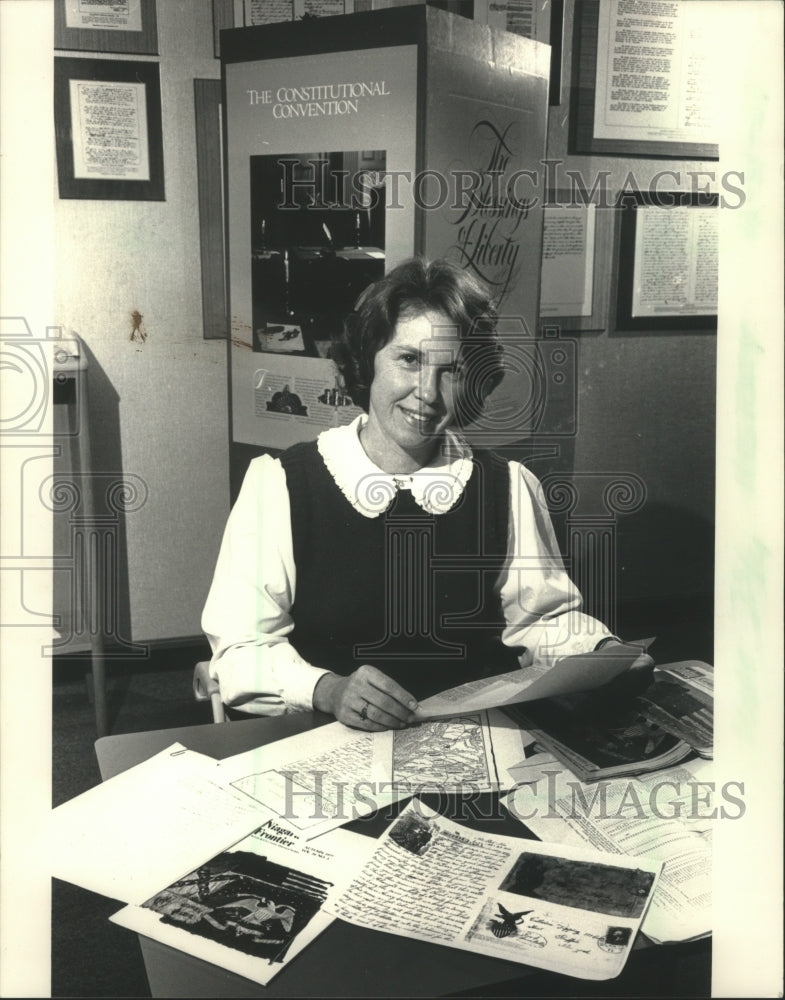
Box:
[194,80,228,340]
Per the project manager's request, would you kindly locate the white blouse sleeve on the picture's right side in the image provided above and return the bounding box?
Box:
[498,462,613,666]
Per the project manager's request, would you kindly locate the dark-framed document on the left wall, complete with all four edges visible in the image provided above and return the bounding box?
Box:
[54,56,165,201]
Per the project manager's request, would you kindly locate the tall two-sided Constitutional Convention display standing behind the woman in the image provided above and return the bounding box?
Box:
[222,7,549,449]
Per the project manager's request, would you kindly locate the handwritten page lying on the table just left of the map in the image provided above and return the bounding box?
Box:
[218,722,407,840]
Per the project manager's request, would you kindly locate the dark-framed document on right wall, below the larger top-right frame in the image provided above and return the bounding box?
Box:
[616,191,719,333]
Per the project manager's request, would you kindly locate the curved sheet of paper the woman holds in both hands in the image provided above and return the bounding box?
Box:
[416,639,654,719]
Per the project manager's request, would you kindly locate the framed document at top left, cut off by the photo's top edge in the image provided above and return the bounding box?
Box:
[54,0,158,55]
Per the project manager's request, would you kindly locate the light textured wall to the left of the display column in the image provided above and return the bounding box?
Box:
[55,0,229,642]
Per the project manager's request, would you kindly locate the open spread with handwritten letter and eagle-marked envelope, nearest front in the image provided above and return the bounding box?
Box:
[328,799,661,979]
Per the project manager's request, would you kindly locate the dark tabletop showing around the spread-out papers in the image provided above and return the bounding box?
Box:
[95,713,710,997]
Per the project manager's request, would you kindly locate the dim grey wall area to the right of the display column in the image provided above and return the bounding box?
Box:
[548,0,719,658]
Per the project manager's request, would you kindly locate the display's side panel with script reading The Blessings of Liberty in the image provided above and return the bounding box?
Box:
[420,18,548,447]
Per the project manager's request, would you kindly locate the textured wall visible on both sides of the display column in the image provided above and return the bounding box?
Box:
[55,0,717,641]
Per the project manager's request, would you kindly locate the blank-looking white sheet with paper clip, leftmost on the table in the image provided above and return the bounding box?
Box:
[46,743,269,903]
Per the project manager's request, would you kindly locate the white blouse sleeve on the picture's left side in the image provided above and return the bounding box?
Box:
[202,455,327,715]
